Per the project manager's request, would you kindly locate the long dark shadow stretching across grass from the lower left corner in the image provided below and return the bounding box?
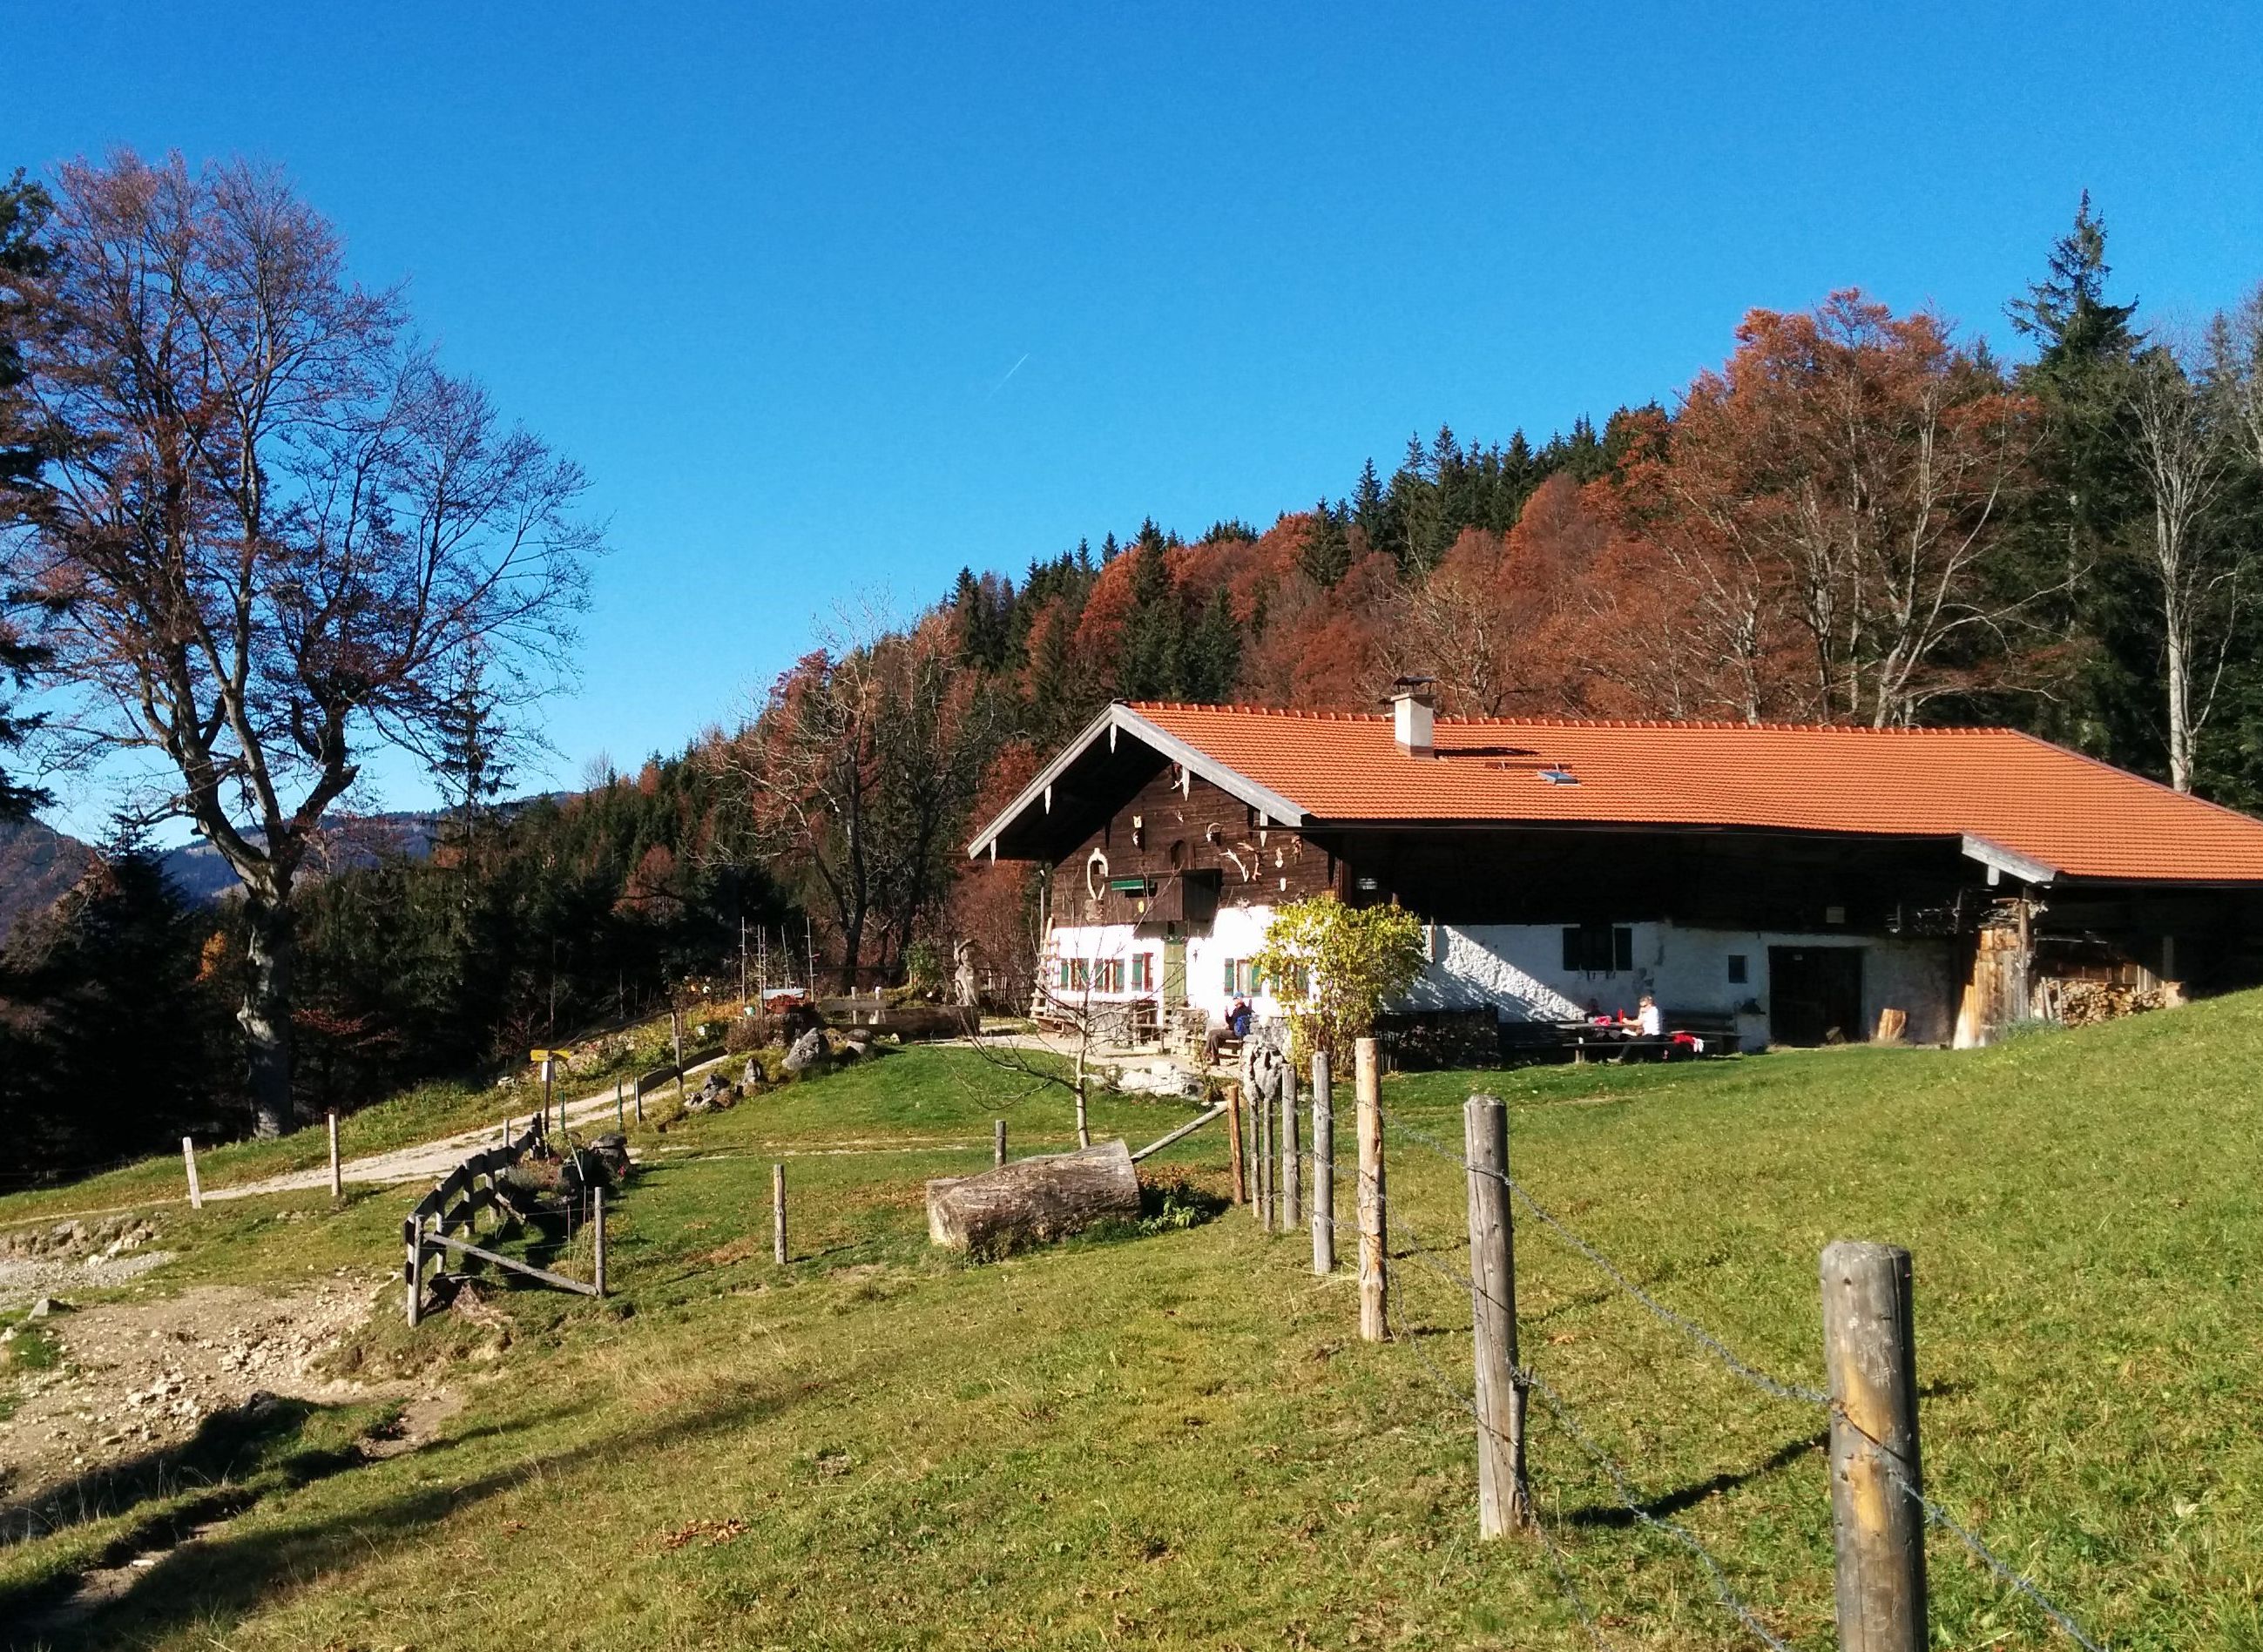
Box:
[22,1379,837,1652]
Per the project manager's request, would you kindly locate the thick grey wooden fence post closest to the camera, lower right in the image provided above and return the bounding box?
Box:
[1821,1240,1926,1652]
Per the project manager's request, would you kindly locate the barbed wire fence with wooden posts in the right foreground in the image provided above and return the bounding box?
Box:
[1246,1041,2107,1652]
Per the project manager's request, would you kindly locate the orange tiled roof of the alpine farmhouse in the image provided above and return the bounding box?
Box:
[1132,704,2263,882]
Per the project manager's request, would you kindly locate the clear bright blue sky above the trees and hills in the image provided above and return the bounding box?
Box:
[0,0,2263,828]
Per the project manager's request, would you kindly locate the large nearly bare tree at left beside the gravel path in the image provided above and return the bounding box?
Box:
[11,154,599,1134]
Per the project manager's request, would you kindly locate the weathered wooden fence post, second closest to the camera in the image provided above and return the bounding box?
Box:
[1462,1096,1532,1536]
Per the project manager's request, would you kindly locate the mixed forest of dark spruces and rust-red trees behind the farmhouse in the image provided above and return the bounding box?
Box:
[0,181,2263,1175]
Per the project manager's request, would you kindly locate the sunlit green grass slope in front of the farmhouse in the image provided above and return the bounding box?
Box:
[0,995,2263,1652]
